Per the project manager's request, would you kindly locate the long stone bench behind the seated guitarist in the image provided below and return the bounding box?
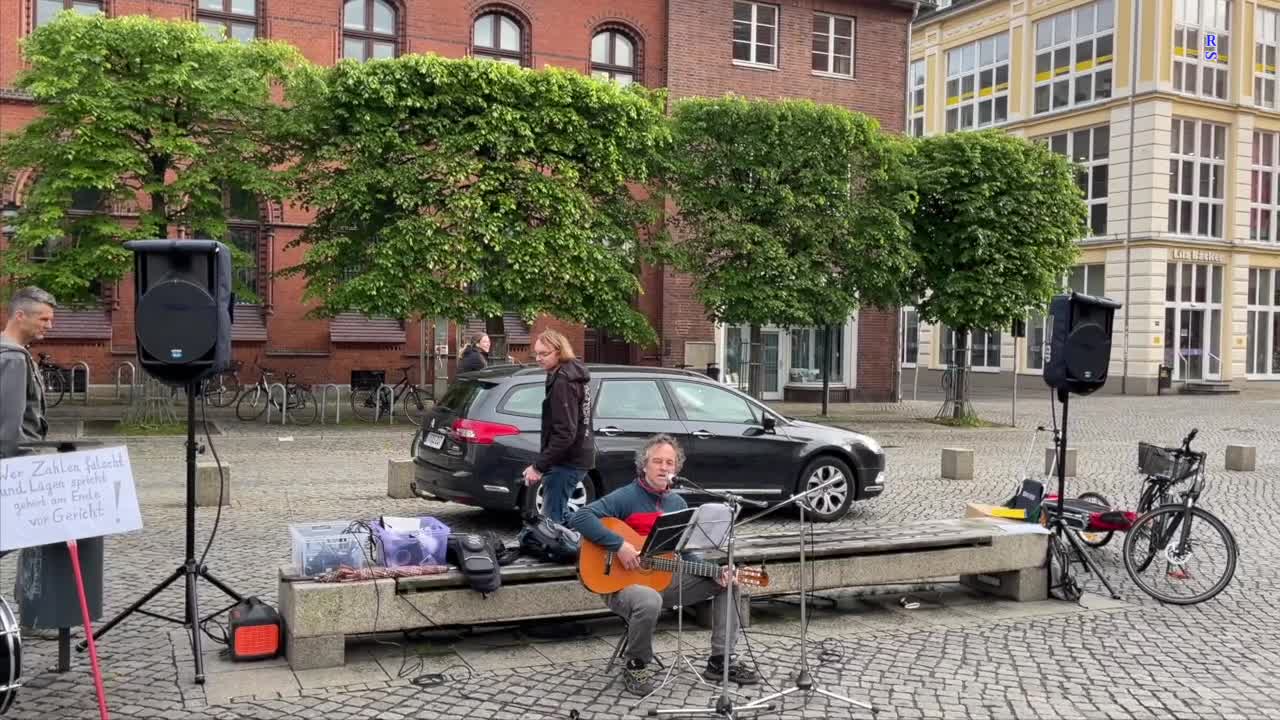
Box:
[279,519,1048,670]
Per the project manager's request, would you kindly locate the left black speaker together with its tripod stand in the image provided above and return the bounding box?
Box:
[78,240,243,683]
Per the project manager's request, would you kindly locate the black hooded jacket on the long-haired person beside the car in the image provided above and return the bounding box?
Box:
[534,360,595,473]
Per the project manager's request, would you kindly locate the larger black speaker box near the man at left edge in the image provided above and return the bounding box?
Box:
[124,240,236,386]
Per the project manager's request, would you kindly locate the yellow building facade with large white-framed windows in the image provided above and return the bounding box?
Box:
[902,0,1280,393]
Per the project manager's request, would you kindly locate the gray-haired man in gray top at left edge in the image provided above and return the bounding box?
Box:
[0,287,58,457]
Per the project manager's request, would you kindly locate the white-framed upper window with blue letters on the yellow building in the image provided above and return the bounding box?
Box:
[1172,0,1231,100]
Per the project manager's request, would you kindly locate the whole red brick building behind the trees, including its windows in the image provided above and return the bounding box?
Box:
[0,0,915,400]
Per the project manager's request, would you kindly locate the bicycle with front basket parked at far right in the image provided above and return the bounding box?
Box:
[1123,429,1239,605]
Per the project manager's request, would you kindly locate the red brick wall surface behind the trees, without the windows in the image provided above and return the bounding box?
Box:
[0,0,910,398]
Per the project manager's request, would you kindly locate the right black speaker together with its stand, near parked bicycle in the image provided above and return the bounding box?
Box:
[1044,292,1120,598]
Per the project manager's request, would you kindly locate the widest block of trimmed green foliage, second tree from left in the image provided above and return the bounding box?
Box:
[283,55,669,342]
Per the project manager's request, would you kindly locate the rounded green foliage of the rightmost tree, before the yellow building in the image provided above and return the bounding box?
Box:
[911,131,1087,331]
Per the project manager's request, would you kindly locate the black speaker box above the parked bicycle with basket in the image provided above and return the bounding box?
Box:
[1044,292,1120,395]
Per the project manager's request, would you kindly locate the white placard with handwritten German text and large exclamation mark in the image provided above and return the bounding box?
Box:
[0,446,142,550]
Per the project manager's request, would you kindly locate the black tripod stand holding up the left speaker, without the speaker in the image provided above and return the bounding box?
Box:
[76,380,243,684]
